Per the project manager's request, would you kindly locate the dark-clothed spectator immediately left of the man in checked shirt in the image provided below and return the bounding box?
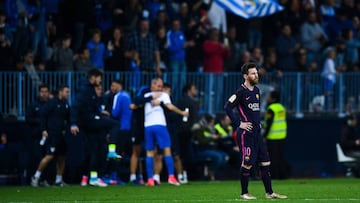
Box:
[105,27,127,71]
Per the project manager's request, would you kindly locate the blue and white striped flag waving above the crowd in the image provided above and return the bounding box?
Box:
[215,0,284,19]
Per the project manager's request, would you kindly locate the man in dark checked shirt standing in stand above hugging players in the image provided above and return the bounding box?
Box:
[125,18,161,75]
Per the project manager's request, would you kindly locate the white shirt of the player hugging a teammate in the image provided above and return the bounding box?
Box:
[144,92,171,127]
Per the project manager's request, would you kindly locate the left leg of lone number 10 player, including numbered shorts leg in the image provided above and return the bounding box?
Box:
[236,129,256,199]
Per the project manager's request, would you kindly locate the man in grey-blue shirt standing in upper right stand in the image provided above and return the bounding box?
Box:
[301,11,328,64]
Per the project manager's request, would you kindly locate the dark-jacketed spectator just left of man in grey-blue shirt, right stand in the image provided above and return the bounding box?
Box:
[276,24,300,71]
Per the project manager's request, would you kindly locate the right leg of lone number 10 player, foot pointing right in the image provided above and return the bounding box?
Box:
[256,136,287,199]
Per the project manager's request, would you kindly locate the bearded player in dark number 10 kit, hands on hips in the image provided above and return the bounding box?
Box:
[224,63,287,200]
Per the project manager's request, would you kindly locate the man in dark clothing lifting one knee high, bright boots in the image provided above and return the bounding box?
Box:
[70,69,121,187]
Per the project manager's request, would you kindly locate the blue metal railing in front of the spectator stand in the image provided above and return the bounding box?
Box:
[0,72,360,118]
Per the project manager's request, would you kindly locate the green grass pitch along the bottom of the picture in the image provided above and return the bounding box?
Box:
[0,178,360,203]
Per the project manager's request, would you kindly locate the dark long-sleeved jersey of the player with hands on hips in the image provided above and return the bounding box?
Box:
[224,84,260,129]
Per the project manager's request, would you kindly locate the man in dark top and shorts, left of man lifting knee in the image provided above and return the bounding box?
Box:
[31,85,70,187]
